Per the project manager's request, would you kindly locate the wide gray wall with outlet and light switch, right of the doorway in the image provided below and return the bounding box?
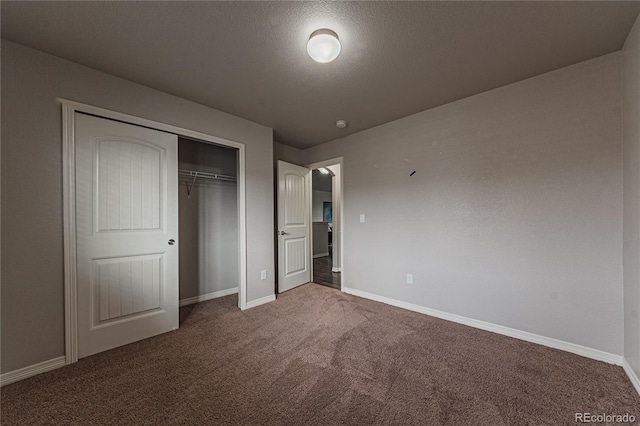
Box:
[305,52,623,355]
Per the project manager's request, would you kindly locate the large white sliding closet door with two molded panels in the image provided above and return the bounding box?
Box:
[75,113,178,358]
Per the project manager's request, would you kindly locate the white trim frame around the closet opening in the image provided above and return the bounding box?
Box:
[58,98,247,364]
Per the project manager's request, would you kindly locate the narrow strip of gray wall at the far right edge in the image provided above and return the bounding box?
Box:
[622,18,640,376]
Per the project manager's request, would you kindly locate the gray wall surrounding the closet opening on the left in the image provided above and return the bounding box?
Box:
[0,40,274,372]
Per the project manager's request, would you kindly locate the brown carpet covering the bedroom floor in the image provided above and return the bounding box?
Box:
[0,284,640,426]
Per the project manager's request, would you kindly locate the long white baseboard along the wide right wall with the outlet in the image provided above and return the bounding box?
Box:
[342,287,623,365]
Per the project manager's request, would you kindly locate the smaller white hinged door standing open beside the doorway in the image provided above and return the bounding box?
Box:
[278,161,311,293]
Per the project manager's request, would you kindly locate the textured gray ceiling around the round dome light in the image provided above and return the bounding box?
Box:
[1,1,640,148]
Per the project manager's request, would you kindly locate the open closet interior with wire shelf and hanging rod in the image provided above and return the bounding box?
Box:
[178,137,239,306]
